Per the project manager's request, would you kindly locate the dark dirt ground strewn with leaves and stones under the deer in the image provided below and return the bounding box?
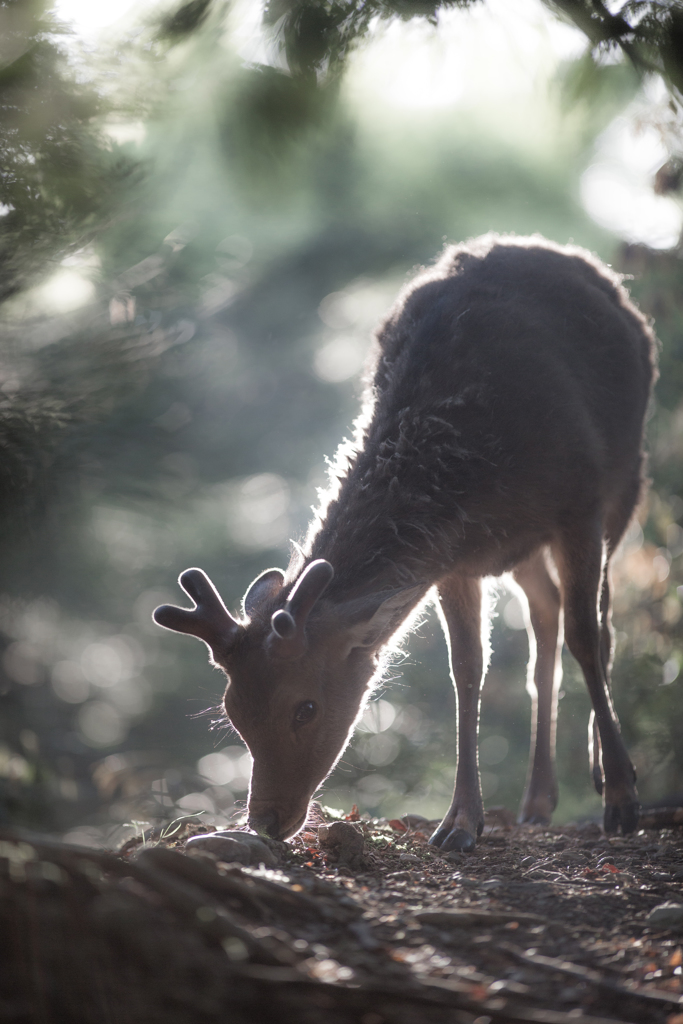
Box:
[0,810,683,1024]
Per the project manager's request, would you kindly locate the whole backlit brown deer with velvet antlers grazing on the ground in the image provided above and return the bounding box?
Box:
[154,233,656,853]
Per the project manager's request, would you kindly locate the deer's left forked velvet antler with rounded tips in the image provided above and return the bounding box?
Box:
[153,569,243,660]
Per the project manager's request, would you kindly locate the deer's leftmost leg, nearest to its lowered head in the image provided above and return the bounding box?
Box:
[429,577,484,851]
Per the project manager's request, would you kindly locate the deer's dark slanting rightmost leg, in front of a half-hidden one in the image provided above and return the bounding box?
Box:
[553,520,639,833]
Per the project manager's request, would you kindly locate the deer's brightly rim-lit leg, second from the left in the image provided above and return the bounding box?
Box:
[513,549,562,824]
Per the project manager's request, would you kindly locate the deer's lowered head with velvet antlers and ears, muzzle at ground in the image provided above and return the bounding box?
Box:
[154,559,426,840]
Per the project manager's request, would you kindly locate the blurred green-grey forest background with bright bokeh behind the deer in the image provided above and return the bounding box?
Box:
[0,0,683,844]
